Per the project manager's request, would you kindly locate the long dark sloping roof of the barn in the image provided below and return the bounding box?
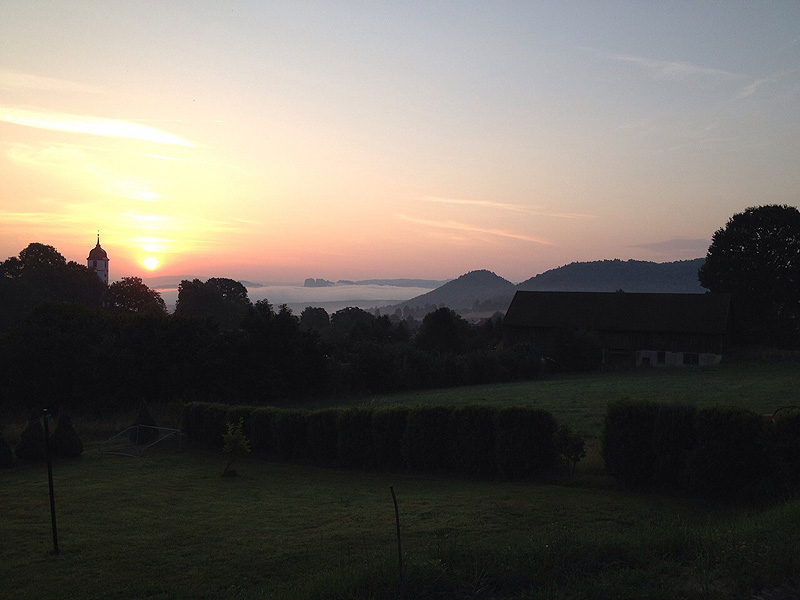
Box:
[503,292,730,334]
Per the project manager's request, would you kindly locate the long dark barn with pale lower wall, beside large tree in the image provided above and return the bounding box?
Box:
[503,291,730,366]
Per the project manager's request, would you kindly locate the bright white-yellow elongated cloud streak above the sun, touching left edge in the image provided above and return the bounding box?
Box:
[0,106,194,147]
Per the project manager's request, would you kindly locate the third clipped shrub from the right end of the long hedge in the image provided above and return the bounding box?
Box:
[402,406,450,473]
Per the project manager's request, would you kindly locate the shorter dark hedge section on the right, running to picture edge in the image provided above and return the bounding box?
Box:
[603,400,800,503]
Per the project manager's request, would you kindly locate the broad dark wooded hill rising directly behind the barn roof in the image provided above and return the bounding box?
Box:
[517,258,705,294]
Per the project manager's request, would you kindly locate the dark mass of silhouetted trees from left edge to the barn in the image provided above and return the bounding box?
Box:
[0,244,540,414]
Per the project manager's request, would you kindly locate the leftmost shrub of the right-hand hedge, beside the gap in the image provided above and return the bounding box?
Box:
[603,399,658,485]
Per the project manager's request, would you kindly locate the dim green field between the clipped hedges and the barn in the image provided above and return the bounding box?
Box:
[334,363,800,436]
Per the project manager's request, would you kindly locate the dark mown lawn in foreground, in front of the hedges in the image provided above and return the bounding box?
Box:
[0,447,800,599]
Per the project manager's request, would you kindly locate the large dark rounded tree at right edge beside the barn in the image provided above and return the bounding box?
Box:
[698,204,800,344]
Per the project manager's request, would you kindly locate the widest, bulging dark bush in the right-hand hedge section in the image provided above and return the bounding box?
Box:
[687,407,773,502]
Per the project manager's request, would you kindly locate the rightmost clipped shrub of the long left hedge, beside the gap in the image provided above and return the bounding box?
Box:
[494,407,556,479]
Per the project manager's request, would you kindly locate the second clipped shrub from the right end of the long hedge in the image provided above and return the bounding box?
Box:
[448,405,497,477]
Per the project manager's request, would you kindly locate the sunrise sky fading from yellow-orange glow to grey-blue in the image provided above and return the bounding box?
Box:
[0,0,800,283]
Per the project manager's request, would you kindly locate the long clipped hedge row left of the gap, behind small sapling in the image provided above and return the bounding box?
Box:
[183,403,558,479]
